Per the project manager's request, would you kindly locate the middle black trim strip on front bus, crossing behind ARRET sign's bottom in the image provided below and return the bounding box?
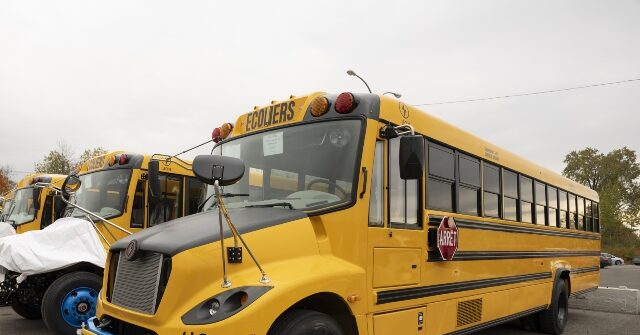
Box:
[427,250,600,262]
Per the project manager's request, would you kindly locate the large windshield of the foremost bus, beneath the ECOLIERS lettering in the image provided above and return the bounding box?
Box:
[204,119,362,210]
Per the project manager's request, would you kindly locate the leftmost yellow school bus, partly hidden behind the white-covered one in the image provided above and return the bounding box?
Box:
[4,173,67,234]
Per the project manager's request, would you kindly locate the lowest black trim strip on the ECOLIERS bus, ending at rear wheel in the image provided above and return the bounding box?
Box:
[376,272,551,305]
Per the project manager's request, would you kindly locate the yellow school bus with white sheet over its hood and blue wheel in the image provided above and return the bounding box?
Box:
[0,151,204,334]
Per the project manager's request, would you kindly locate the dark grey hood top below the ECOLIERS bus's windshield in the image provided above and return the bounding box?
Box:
[110,207,307,256]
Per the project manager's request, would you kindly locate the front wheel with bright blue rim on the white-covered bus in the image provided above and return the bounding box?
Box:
[42,271,102,335]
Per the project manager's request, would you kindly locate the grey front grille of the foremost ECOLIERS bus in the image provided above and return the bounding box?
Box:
[111,252,162,314]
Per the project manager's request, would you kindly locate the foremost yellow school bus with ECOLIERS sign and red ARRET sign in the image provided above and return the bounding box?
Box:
[82,92,600,335]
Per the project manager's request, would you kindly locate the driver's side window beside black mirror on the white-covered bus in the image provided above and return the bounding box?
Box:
[149,174,182,227]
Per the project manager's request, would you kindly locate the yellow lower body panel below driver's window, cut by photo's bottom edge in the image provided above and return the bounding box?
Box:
[373,307,426,335]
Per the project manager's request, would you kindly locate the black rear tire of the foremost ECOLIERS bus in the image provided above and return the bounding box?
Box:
[538,280,569,335]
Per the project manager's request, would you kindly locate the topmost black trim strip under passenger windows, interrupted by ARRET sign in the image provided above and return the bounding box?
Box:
[429,216,600,240]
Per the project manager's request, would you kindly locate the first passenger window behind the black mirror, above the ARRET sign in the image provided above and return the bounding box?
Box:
[427,143,455,212]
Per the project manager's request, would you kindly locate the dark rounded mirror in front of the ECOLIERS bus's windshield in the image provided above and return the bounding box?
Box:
[192,155,244,186]
